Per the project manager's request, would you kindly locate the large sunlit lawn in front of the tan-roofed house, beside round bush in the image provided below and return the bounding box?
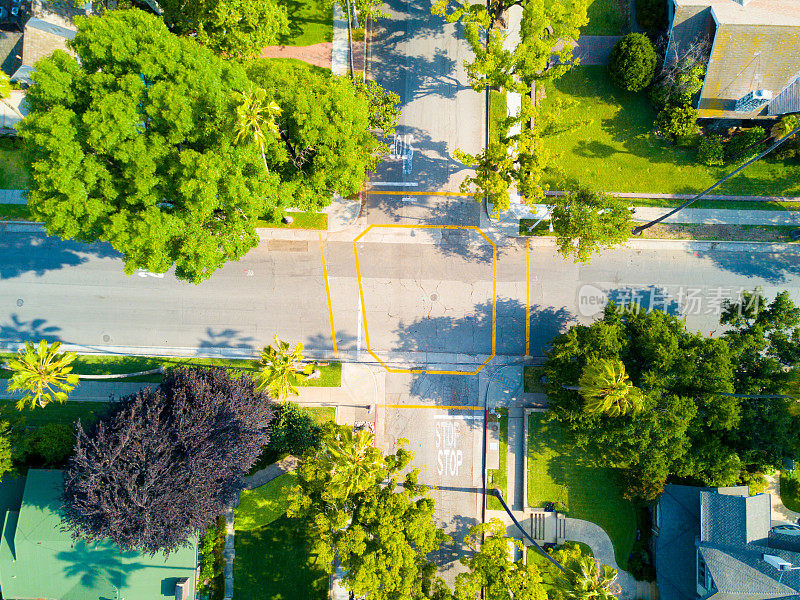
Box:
[542,67,800,196]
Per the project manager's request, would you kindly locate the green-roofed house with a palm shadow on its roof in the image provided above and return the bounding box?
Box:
[0,469,197,600]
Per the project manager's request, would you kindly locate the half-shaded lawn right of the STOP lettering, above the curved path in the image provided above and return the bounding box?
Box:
[528,413,636,568]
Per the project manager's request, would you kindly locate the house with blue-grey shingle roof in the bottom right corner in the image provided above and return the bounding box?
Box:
[655,484,800,600]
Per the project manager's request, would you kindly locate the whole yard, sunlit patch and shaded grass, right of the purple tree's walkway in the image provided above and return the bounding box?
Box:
[233,473,328,600]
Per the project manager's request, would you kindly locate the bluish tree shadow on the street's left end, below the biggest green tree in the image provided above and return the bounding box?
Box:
[0,231,122,279]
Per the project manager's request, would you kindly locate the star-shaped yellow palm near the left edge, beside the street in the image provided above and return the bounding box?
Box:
[7,340,78,410]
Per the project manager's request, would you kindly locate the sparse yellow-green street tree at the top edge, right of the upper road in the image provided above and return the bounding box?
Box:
[431,0,589,94]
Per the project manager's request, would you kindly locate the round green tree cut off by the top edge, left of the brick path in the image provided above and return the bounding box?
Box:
[159,0,289,58]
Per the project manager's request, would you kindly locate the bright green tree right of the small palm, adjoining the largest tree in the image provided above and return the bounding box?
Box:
[247,60,397,210]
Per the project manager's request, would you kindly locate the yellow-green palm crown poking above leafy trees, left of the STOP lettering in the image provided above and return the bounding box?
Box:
[320,426,384,502]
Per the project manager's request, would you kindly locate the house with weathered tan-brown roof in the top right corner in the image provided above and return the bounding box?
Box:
[665,0,800,119]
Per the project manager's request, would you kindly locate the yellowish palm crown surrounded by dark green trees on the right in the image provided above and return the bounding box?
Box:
[578,358,642,417]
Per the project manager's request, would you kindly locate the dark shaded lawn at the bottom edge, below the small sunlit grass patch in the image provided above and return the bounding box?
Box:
[233,516,328,600]
